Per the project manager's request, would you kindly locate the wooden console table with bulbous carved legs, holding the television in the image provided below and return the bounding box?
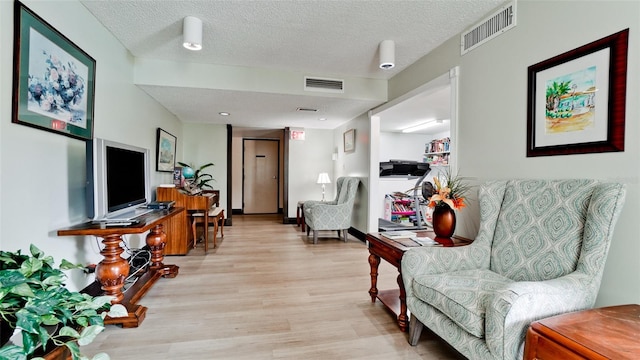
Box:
[58,207,184,328]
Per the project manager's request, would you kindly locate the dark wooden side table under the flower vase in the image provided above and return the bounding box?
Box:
[367,230,471,331]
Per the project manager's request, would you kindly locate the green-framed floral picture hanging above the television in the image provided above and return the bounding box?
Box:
[11,2,96,140]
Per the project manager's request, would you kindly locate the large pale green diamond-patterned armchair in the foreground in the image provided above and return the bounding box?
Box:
[402,179,625,360]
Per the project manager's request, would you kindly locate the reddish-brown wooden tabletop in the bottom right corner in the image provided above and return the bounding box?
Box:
[524,304,640,360]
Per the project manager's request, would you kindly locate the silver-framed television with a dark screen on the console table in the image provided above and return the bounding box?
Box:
[86,138,151,220]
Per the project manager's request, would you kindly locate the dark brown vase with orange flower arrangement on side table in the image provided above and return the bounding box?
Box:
[429,171,470,238]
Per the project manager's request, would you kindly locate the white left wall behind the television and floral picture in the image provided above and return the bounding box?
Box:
[0,1,182,289]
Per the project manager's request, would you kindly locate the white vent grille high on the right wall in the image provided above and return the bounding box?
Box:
[460,0,516,55]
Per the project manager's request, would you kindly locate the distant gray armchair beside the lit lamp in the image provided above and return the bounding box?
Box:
[303,177,360,244]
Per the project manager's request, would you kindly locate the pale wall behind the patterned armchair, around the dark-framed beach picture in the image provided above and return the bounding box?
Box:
[389,0,640,306]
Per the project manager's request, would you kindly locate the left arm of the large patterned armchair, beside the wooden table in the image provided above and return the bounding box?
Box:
[401,242,490,297]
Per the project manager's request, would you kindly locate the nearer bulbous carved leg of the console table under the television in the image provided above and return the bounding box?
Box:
[96,234,129,304]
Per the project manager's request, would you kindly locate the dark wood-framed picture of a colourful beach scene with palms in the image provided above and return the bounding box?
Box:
[527,29,629,157]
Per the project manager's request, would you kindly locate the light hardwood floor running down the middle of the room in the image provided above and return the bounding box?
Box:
[83,215,464,360]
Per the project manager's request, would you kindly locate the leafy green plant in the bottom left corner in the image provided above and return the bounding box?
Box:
[0,245,127,360]
